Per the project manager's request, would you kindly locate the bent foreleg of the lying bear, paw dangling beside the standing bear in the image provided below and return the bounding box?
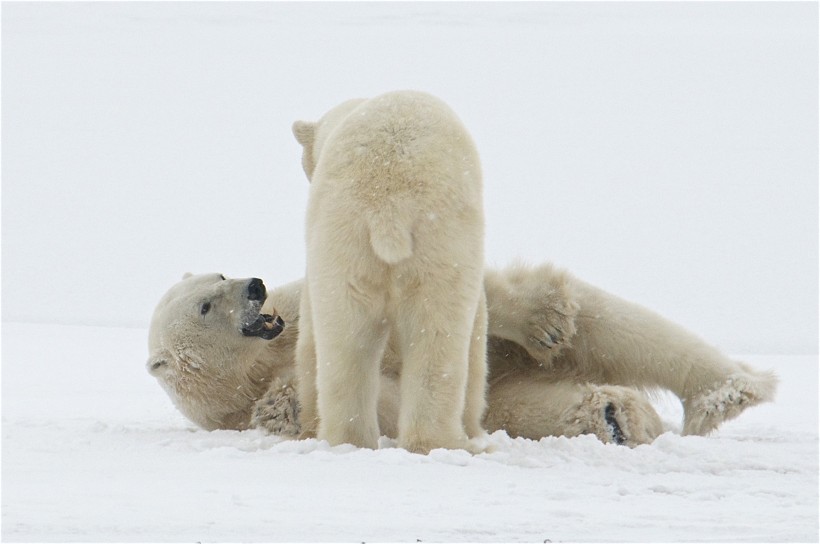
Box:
[484,264,579,365]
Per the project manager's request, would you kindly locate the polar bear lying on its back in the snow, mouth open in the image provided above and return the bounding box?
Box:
[147,264,777,447]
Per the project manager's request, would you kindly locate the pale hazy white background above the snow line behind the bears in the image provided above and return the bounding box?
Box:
[2,2,818,353]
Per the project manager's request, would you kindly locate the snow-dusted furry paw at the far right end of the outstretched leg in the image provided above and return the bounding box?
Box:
[683,367,777,435]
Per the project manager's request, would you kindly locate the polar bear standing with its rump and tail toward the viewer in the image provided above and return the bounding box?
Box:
[293,91,487,453]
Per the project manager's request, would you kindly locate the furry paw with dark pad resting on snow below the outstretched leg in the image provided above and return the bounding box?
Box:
[568,385,663,447]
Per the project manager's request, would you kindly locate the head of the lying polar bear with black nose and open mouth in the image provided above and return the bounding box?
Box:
[147,274,285,429]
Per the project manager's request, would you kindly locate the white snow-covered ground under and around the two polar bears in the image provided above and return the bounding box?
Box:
[2,323,818,542]
